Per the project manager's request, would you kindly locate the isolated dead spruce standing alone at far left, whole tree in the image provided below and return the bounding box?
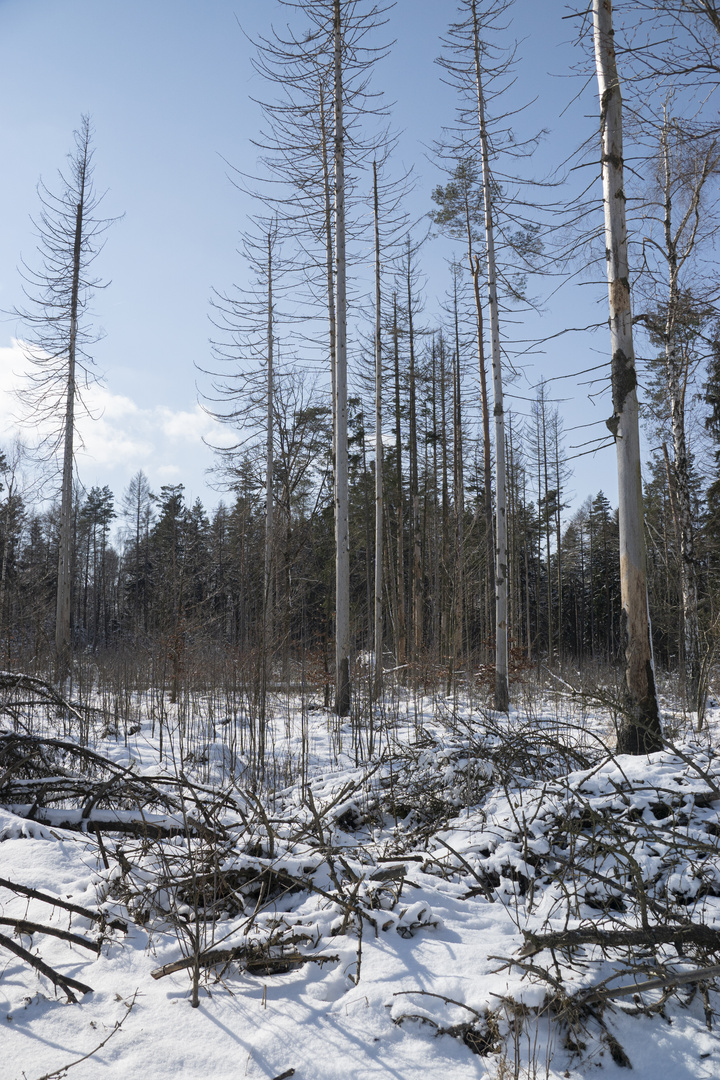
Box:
[14,116,112,681]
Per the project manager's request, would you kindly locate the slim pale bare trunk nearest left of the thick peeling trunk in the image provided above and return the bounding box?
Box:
[472,0,510,713]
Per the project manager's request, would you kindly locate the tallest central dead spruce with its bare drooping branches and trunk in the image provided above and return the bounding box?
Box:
[249,0,395,716]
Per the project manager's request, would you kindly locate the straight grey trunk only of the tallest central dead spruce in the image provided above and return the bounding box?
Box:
[332,0,351,716]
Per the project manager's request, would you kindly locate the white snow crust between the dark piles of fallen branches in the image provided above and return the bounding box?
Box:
[0,697,720,1080]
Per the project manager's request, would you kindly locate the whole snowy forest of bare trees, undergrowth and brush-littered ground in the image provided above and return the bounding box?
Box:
[0,0,720,1080]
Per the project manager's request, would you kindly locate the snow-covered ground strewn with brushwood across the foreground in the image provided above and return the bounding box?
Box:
[0,693,720,1080]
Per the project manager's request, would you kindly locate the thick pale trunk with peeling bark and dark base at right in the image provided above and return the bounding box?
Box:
[593,0,663,754]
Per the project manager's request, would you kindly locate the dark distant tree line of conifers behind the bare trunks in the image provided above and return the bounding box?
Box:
[0,333,720,700]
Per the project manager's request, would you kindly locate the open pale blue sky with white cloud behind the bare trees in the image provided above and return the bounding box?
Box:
[0,0,614,514]
